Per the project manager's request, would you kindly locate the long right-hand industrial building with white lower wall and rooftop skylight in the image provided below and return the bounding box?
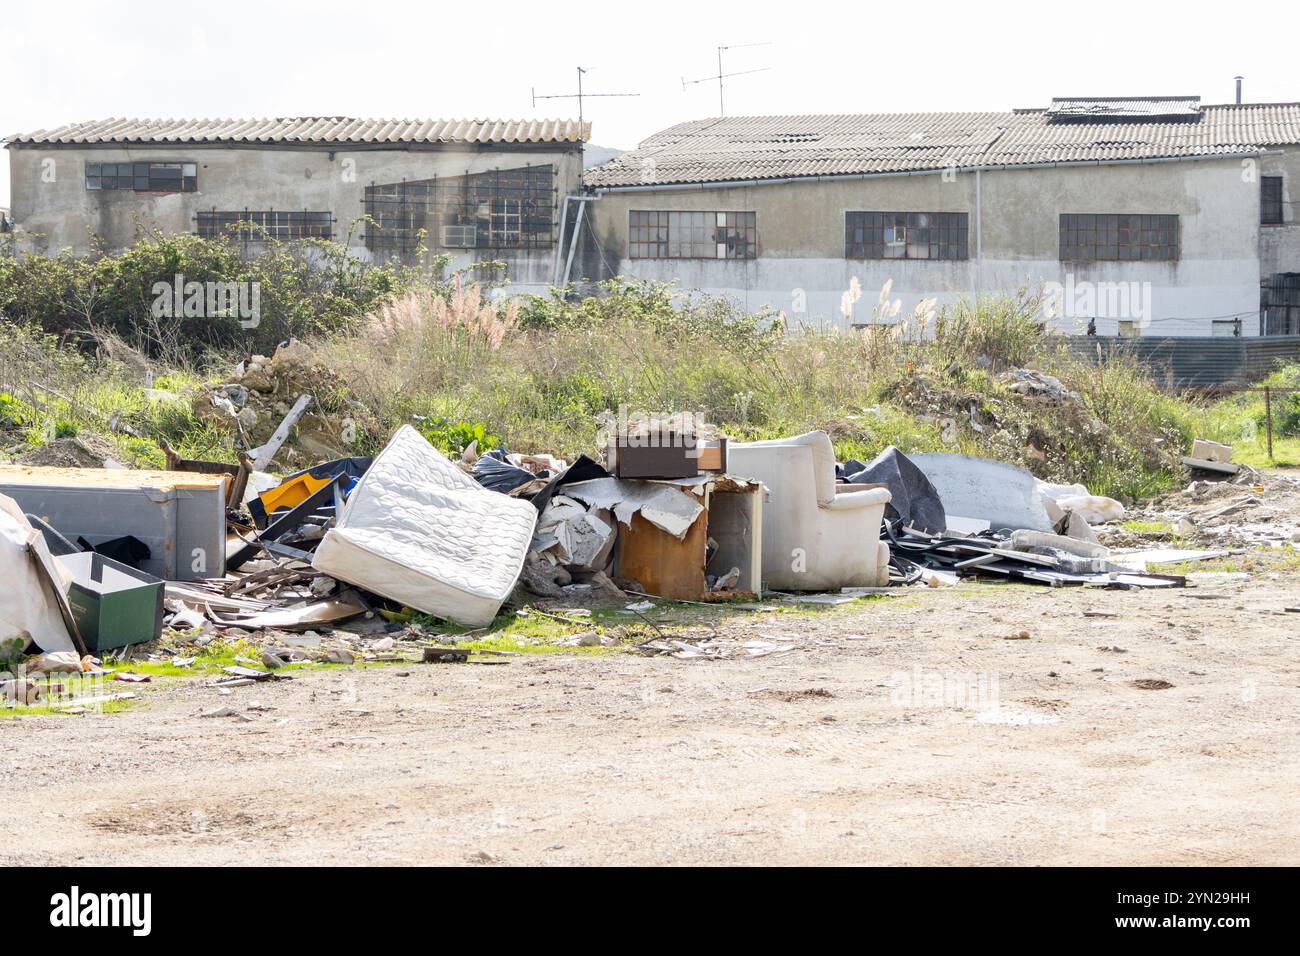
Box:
[579,96,1300,336]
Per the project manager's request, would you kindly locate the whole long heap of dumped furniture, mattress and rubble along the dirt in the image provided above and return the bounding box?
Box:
[0,403,1258,680]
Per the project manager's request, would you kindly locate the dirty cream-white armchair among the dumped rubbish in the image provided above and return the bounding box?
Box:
[727,432,891,591]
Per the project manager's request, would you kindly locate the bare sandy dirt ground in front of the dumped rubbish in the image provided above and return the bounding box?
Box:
[0,575,1300,865]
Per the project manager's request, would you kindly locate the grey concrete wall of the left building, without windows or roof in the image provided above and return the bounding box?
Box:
[9,146,582,290]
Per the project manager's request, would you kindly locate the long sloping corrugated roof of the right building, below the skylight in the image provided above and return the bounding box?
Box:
[584,103,1300,189]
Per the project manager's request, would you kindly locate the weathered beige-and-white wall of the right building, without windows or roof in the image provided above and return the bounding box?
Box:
[584,159,1260,336]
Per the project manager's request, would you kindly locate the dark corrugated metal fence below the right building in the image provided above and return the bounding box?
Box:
[1069,336,1300,390]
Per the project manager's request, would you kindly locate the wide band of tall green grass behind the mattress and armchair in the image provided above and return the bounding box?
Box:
[321,282,1237,499]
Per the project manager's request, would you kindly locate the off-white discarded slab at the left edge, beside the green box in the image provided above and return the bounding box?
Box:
[0,494,75,652]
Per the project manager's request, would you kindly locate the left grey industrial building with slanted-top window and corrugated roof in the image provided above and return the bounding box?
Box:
[8,117,590,289]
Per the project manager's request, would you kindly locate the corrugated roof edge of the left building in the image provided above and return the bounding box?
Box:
[8,116,592,146]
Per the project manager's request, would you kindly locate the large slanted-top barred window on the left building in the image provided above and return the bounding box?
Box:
[365,165,555,256]
